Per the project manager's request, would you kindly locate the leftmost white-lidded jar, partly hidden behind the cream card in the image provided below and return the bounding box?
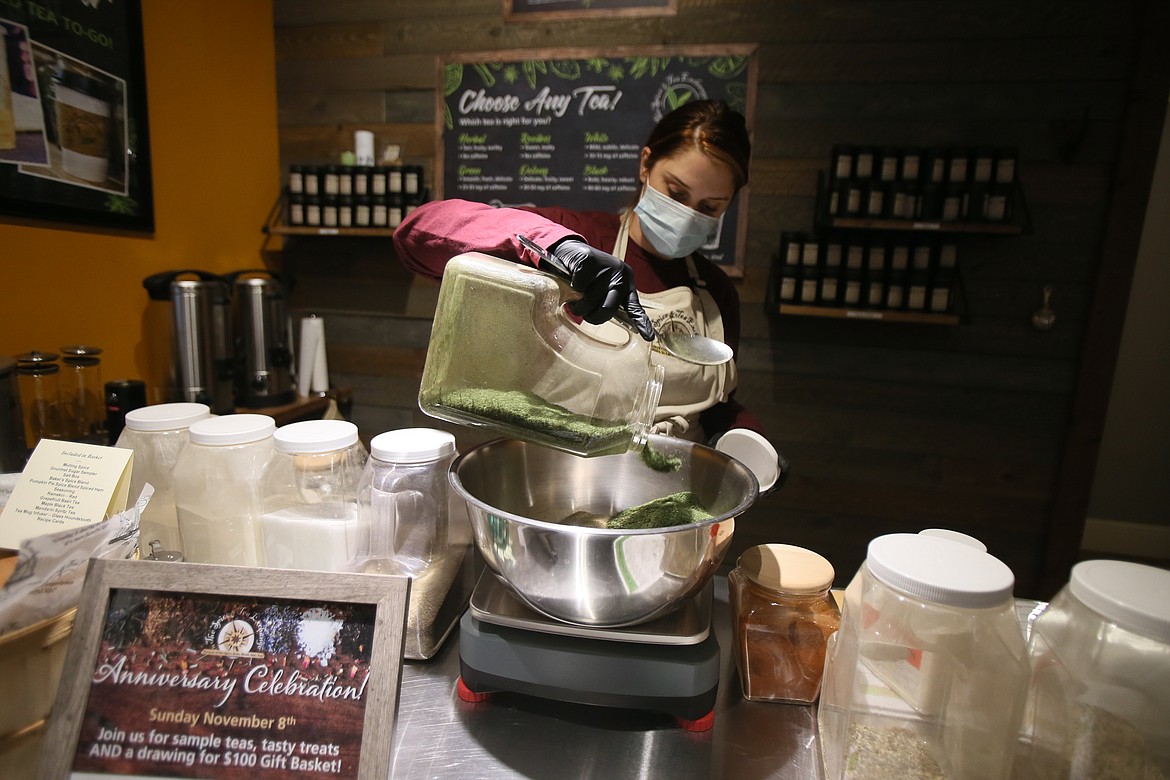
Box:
[115,403,212,553]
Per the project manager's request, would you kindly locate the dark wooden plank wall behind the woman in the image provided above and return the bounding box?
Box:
[274,0,1164,596]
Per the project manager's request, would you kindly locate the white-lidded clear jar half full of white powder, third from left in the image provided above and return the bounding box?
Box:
[260,420,366,572]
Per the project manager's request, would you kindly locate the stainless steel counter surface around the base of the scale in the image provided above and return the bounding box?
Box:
[391,577,824,780]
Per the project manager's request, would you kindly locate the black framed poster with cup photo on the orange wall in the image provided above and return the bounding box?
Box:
[0,0,154,232]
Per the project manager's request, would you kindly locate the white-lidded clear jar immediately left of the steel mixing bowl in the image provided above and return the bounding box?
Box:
[352,428,455,577]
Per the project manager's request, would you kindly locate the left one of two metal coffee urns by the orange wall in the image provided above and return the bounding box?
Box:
[143,270,235,414]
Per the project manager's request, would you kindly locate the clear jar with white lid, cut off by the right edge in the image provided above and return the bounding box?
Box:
[1025,560,1170,780]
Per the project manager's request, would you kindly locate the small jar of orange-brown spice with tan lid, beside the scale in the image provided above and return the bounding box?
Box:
[728,544,841,704]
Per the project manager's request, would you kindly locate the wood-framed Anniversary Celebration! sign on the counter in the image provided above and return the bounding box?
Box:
[37,560,410,780]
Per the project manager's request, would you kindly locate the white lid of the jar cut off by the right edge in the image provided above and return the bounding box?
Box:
[1068,560,1170,642]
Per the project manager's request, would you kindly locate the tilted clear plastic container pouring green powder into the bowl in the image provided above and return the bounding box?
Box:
[419,253,663,456]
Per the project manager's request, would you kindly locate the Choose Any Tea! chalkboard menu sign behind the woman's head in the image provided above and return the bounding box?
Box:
[435,46,756,275]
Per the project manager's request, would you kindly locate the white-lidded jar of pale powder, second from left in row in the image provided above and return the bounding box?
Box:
[174,414,276,566]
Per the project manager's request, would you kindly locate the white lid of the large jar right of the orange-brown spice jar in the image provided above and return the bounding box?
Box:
[866,533,1016,608]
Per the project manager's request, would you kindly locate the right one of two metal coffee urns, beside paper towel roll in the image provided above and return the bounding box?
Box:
[225,269,296,409]
